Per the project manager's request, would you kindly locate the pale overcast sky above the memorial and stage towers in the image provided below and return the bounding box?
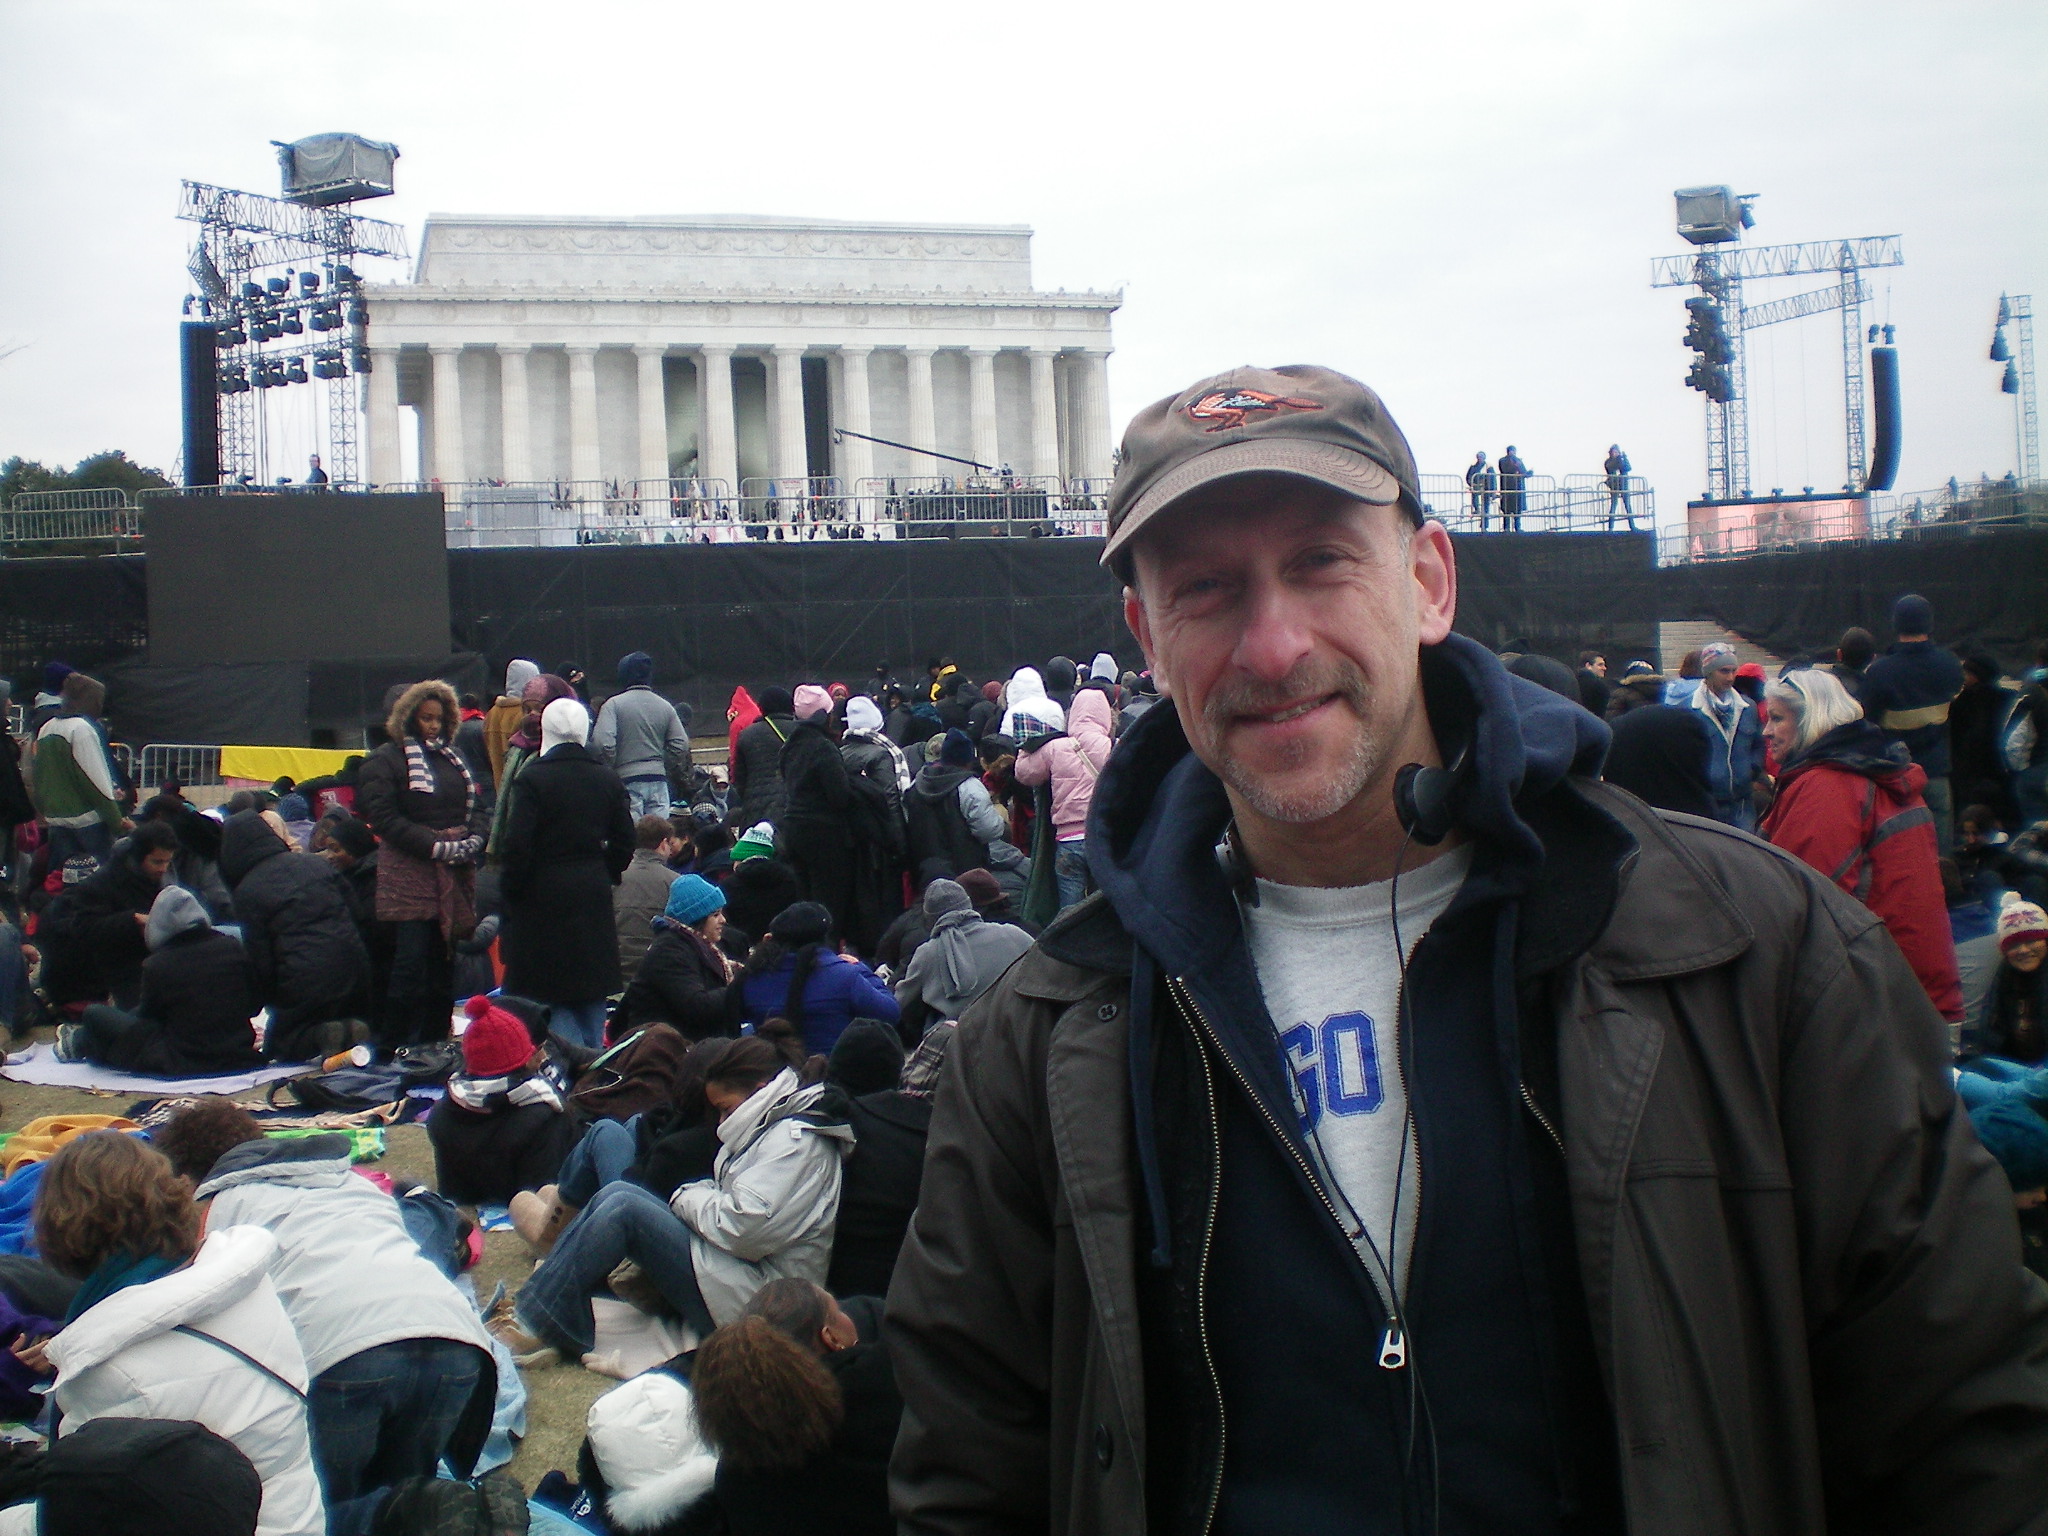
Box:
[0,0,2048,522]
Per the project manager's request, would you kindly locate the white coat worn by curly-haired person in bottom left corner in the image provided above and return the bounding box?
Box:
[47,1227,328,1536]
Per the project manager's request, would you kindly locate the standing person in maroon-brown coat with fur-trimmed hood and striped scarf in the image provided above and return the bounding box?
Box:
[356,678,489,1049]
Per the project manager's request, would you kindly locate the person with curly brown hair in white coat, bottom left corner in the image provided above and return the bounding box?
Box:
[35,1130,328,1536]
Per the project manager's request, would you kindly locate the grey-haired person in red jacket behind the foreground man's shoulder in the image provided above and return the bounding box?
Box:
[1759,670,1962,1026]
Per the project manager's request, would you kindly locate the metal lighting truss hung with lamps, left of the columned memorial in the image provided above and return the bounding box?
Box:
[178,182,408,485]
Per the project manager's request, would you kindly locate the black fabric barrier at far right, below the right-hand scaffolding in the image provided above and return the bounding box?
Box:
[1657,528,2048,672]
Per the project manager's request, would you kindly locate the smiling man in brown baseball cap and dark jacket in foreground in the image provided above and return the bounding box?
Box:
[889,367,2048,1536]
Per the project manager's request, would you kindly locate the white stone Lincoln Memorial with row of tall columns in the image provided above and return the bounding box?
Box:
[367,215,1122,540]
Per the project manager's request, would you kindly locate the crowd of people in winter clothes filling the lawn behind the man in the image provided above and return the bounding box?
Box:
[0,518,2048,1536]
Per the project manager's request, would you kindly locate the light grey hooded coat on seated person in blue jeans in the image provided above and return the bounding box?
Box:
[668,1067,854,1327]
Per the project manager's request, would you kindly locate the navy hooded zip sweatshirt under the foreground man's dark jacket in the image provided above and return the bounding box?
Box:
[1087,635,1626,1536]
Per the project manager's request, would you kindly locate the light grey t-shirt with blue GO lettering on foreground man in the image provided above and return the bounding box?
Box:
[1245,848,1473,1303]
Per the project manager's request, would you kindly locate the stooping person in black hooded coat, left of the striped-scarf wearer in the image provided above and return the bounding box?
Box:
[221,811,371,1061]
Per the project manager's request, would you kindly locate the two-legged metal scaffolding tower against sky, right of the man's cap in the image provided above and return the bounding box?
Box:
[1651,236,1905,502]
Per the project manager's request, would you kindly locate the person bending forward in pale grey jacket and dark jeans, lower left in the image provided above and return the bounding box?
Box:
[156,1098,498,1509]
